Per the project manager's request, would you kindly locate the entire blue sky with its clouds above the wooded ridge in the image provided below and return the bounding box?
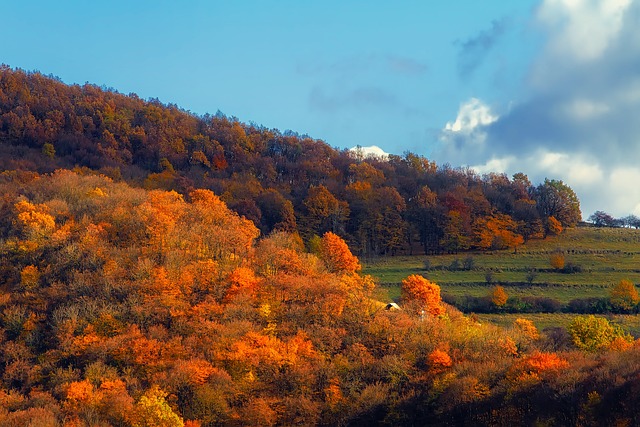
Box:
[0,0,640,218]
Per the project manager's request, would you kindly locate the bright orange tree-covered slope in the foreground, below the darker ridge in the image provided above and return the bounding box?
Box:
[0,170,640,427]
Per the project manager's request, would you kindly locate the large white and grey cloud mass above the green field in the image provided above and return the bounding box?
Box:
[434,0,640,217]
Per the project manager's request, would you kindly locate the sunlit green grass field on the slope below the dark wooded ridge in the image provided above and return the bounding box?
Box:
[364,227,640,310]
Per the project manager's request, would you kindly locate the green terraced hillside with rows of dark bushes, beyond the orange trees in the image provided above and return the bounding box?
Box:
[364,226,640,314]
